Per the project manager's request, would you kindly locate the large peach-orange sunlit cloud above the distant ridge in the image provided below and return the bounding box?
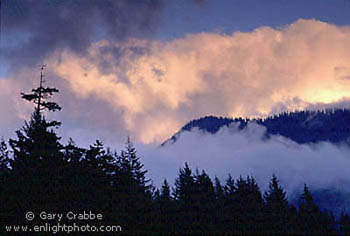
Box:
[48,20,350,143]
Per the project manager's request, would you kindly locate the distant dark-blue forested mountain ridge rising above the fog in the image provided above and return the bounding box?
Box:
[163,109,350,145]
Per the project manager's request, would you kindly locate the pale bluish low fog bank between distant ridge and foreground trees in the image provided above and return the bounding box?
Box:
[137,123,350,212]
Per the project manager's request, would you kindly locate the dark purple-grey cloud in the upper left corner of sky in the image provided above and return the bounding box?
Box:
[1,0,166,66]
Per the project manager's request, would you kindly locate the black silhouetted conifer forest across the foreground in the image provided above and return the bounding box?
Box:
[0,75,350,235]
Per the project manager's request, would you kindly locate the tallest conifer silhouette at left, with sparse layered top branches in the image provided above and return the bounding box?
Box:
[9,65,65,224]
